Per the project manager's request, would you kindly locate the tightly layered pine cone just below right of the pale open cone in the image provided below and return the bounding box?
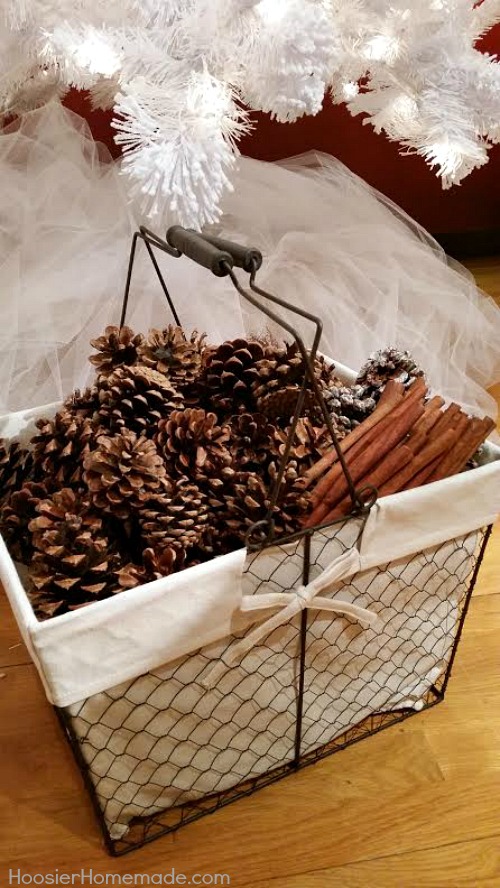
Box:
[139,479,209,552]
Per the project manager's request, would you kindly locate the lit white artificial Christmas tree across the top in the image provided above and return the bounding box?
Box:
[0,0,500,227]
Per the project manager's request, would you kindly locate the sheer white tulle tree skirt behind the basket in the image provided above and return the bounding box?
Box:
[0,103,500,415]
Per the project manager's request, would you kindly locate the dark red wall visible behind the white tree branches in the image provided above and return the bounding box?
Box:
[62,26,500,234]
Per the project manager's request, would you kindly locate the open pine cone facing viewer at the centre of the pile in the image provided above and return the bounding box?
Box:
[155,407,231,481]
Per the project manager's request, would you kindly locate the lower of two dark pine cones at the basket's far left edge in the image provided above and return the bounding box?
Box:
[0,481,48,563]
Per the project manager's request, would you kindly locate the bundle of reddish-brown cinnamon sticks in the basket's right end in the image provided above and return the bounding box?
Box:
[304,378,495,527]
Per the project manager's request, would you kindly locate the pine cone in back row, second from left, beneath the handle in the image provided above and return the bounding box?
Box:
[139,324,206,390]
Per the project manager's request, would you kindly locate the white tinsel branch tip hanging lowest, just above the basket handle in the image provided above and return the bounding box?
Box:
[114,69,252,228]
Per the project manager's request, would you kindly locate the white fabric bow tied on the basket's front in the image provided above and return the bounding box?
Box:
[202,549,378,688]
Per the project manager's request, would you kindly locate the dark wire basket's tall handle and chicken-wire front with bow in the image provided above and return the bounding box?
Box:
[0,227,491,855]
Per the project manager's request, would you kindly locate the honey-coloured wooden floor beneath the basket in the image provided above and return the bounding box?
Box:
[0,259,500,888]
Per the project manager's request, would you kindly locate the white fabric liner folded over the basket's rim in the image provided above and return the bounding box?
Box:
[0,396,500,706]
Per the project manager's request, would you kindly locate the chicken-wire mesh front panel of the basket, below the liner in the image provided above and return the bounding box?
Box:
[57,520,489,855]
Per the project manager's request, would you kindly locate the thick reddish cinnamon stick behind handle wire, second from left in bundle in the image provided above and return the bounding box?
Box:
[305,392,424,527]
